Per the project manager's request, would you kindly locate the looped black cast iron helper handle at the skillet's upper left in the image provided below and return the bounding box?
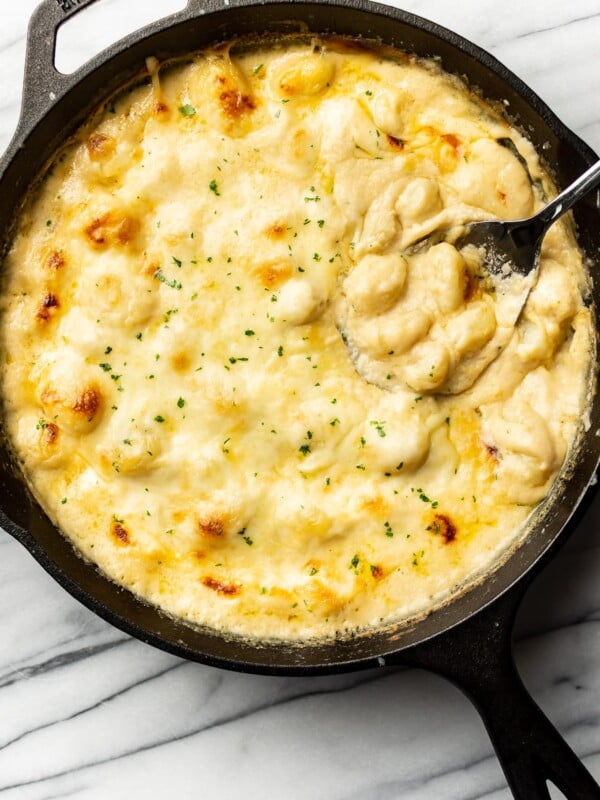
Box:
[19,0,101,128]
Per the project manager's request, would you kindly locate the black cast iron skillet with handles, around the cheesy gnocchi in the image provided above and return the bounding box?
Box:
[0,0,600,800]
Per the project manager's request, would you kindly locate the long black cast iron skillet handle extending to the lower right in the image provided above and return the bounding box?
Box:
[398,589,600,800]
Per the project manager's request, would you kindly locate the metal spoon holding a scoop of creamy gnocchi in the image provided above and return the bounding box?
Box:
[338,162,600,394]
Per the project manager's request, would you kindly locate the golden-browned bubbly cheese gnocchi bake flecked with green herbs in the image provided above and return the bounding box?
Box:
[0,38,593,640]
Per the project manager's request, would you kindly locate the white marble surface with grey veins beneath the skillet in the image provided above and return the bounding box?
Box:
[0,0,600,800]
